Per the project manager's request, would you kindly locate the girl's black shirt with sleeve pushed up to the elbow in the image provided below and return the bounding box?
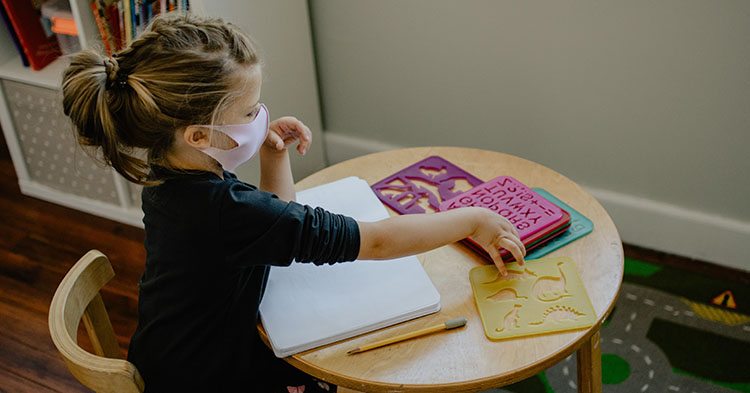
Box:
[128,169,360,392]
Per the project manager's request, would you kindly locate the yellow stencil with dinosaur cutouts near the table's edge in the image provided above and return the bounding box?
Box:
[469,257,596,340]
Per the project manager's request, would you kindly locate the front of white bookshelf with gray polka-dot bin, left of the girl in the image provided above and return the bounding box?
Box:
[0,0,143,226]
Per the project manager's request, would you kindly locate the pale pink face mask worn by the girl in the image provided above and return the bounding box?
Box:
[198,104,269,171]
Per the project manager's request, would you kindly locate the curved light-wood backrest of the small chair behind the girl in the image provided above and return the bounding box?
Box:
[49,250,144,393]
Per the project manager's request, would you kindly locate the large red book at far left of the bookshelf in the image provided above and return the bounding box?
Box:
[1,0,62,71]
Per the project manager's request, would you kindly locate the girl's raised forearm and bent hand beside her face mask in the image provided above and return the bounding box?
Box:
[260,116,312,201]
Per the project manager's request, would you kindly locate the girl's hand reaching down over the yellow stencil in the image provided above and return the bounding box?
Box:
[469,208,526,276]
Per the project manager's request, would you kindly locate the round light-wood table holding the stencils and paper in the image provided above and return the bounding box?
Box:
[259,147,624,392]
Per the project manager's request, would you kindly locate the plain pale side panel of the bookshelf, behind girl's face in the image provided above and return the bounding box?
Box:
[191,0,326,184]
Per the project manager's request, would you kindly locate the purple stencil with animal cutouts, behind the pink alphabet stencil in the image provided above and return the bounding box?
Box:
[371,156,482,214]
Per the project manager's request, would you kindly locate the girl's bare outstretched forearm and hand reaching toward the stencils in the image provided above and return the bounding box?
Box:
[358,207,526,275]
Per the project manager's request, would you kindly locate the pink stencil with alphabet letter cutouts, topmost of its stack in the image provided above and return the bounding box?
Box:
[440,176,563,239]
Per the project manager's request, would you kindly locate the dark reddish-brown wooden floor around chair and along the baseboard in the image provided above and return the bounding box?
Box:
[0,134,750,392]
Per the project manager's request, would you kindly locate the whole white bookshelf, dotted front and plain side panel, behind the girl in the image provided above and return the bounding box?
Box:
[0,0,326,226]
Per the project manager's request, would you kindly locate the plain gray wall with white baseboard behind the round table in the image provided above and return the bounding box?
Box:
[310,0,750,270]
